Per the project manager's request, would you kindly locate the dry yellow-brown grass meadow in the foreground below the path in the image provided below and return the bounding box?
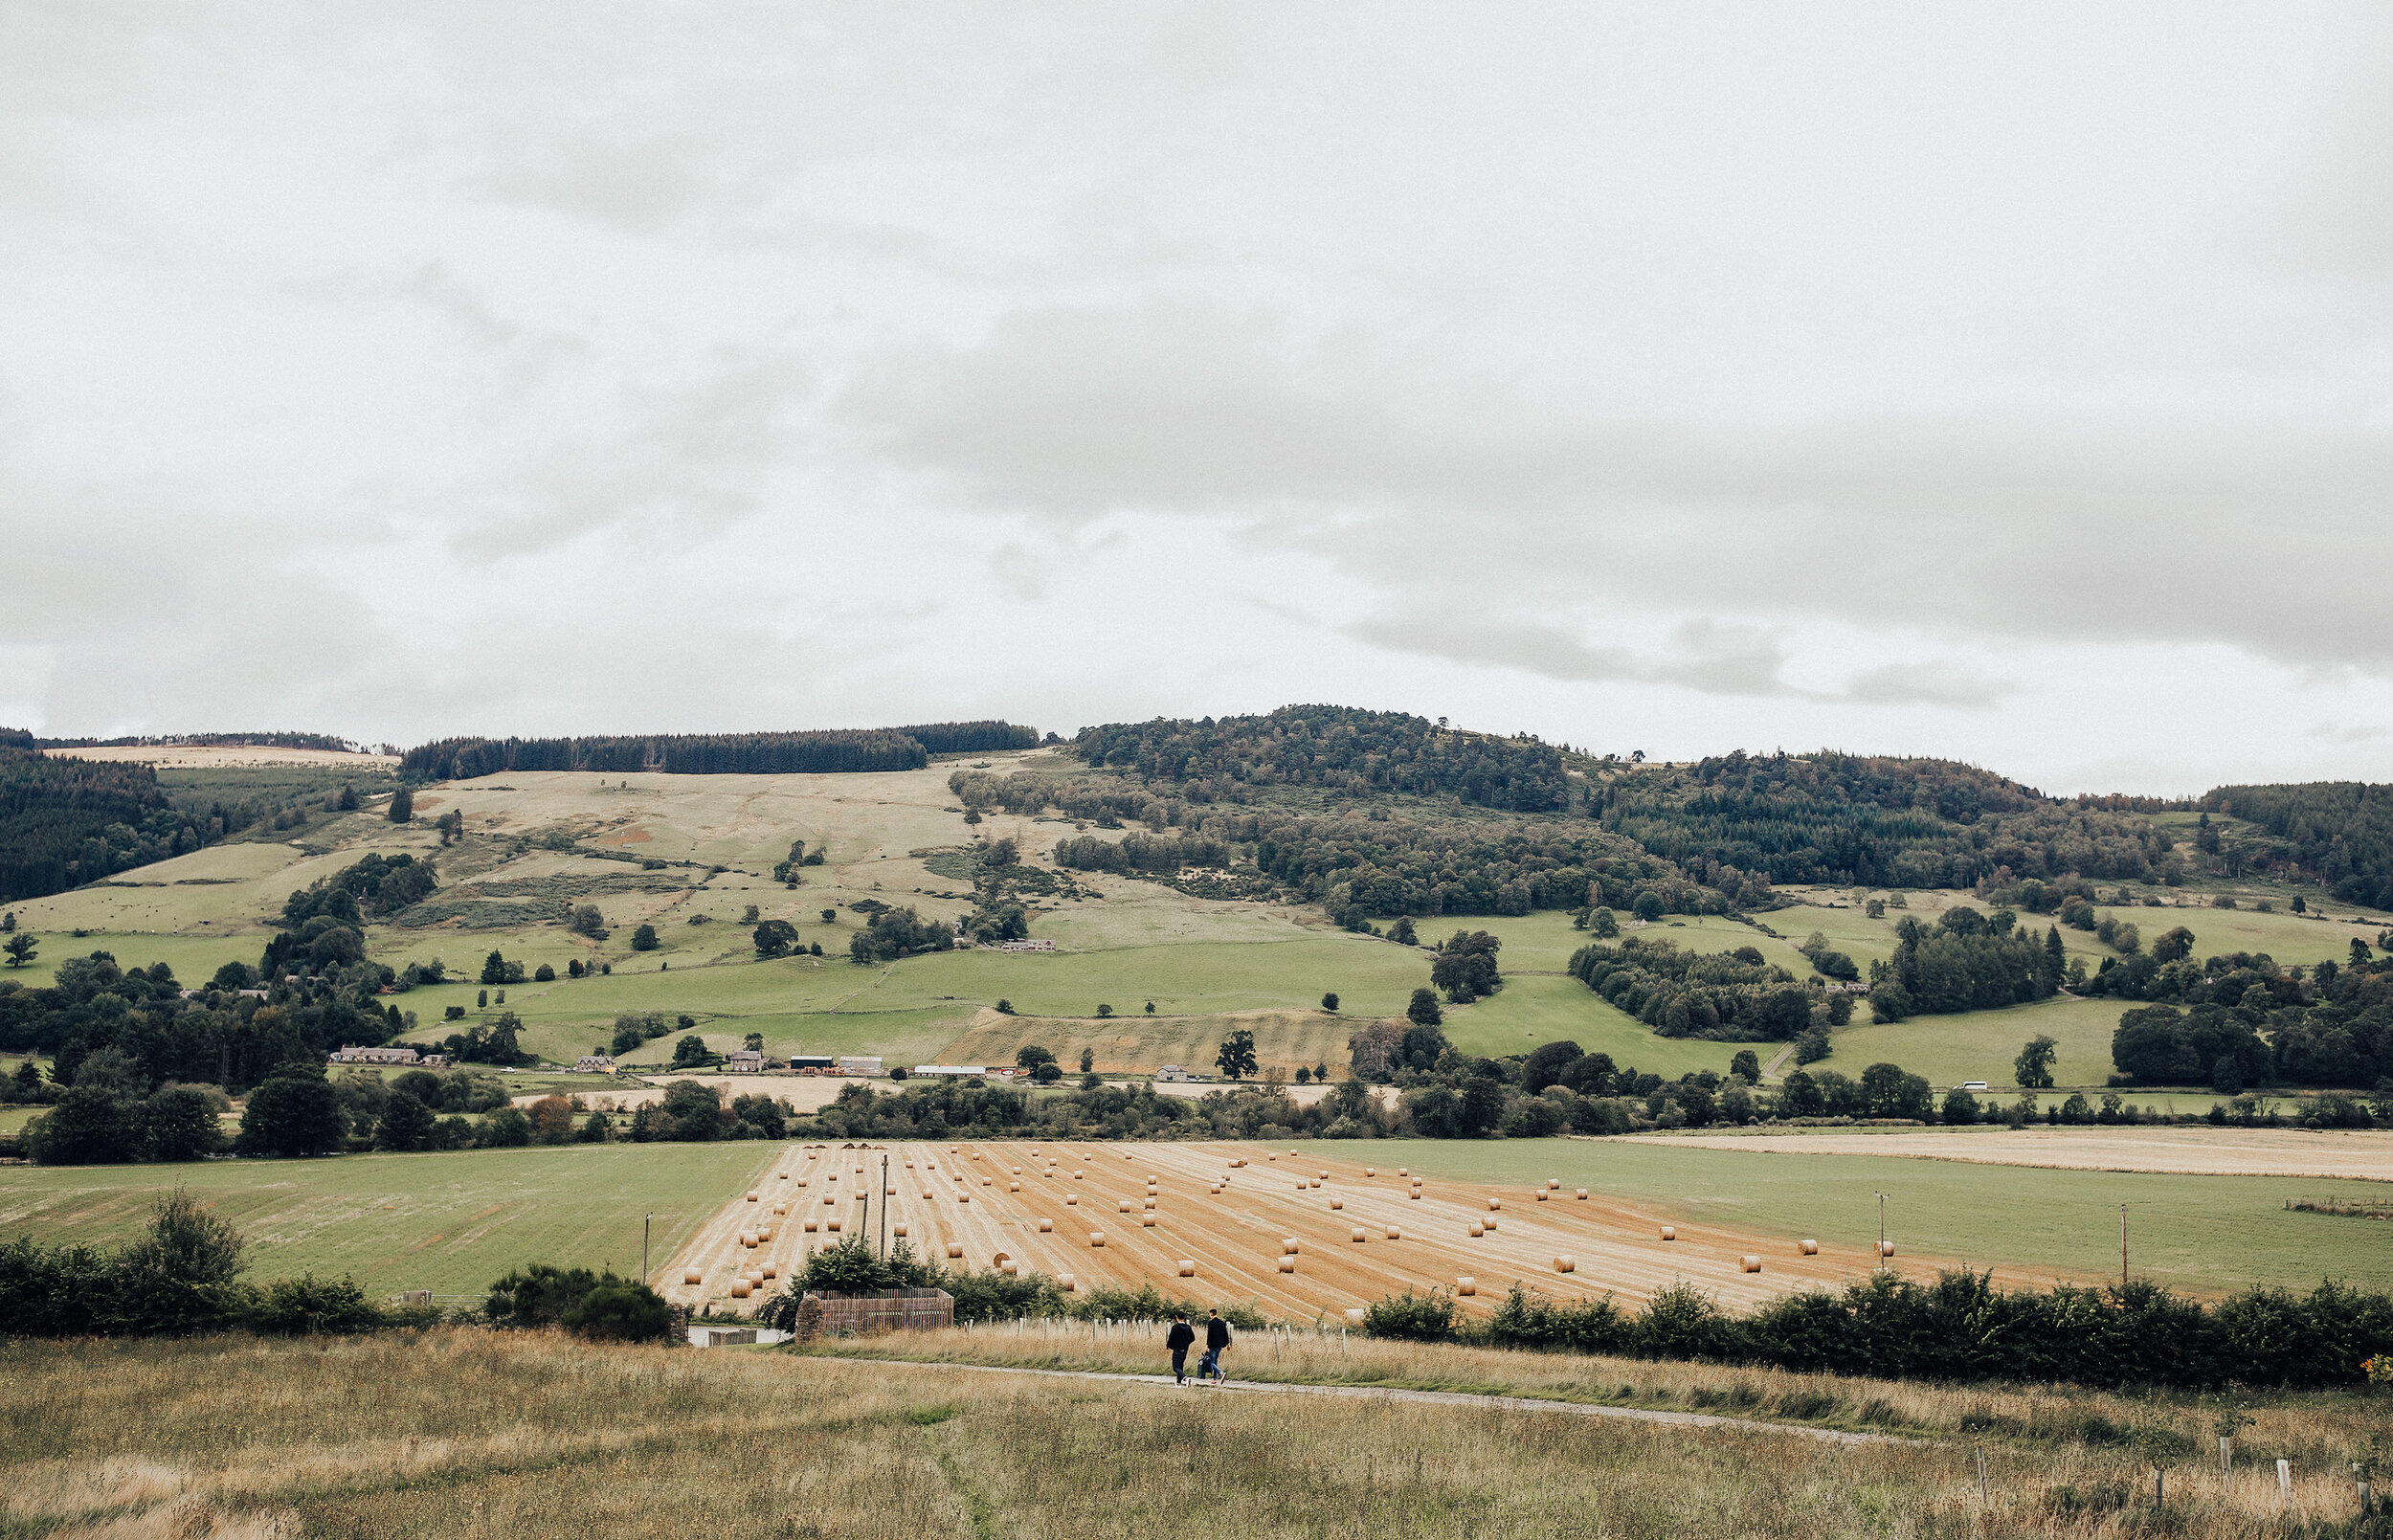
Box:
[0,1332,2359,1540]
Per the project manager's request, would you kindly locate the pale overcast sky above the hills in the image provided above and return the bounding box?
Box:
[0,0,2393,792]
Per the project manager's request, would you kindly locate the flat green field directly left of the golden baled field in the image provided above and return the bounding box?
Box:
[0,1143,783,1294]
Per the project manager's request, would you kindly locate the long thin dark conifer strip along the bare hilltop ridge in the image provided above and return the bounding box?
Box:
[400,723,1039,779]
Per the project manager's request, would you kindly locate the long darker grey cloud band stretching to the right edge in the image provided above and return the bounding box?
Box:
[842,303,2393,669]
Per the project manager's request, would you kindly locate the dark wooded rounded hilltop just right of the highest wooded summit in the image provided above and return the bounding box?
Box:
[1594,751,2171,887]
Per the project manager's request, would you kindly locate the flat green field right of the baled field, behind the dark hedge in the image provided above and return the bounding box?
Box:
[1331,1138,2388,1294]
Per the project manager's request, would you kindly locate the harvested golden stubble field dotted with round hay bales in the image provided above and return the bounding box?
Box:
[659,1141,2027,1320]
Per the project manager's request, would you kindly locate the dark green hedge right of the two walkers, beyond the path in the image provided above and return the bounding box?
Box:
[1364,1270,2393,1396]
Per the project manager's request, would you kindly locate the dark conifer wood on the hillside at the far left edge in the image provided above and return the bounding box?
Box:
[0,748,212,902]
